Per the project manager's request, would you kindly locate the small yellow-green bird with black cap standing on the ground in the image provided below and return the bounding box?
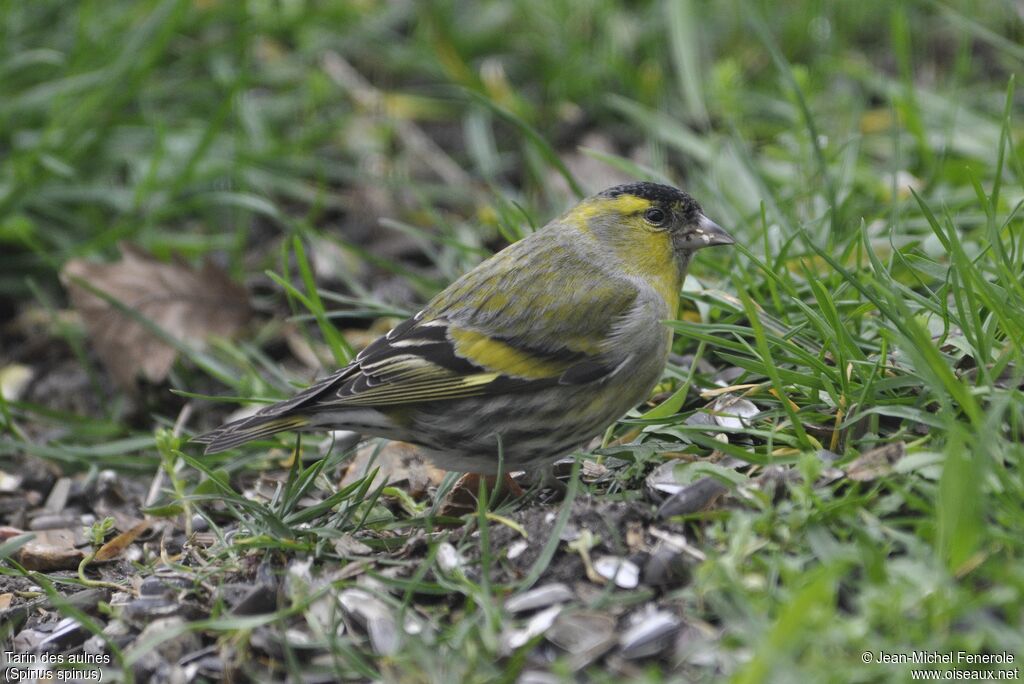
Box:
[195,182,734,475]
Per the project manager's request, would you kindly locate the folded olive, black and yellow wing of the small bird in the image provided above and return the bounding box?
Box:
[267,240,637,416]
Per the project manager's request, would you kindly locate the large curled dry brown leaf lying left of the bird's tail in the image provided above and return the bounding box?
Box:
[60,245,250,390]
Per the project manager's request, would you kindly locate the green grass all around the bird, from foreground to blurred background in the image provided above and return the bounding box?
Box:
[0,0,1024,682]
